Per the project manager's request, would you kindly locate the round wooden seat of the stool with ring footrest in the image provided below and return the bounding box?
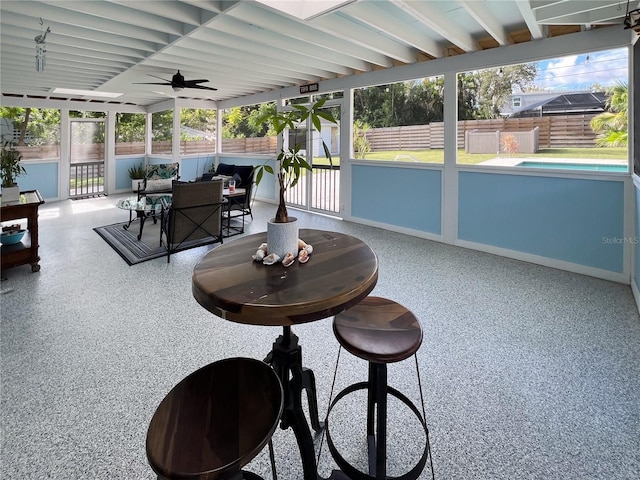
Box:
[333,297,422,363]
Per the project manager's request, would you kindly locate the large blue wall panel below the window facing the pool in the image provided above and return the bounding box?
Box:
[458,172,624,273]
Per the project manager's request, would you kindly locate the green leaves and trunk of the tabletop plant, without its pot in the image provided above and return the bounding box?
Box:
[255,98,338,223]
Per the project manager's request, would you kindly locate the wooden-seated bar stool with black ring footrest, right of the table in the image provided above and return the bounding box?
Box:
[325,297,435,480]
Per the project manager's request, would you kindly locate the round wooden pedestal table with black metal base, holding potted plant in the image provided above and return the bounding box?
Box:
[192,229,378,480]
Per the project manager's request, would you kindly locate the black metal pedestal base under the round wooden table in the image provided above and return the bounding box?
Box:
[265,327,323,480]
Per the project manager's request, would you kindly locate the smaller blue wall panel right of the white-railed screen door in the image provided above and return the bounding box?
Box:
[351,165,442,235]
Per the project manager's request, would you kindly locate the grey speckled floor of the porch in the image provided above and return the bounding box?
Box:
[0,196,640,480]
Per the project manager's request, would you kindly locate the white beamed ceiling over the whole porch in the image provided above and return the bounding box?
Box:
[0,0,637,105]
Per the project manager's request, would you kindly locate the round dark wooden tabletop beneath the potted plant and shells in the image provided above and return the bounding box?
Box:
[193,229,378,326]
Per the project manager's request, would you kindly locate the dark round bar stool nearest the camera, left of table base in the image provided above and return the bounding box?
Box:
[147,358,283,480]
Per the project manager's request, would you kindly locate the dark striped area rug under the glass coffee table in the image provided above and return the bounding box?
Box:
[94,220,216,265]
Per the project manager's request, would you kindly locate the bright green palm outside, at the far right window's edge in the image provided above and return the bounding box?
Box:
[590,83,629,147]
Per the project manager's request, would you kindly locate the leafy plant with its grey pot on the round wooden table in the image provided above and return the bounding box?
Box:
[255,99,338,259]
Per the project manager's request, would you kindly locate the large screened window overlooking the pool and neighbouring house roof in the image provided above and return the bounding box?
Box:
[458,48,628,172]
